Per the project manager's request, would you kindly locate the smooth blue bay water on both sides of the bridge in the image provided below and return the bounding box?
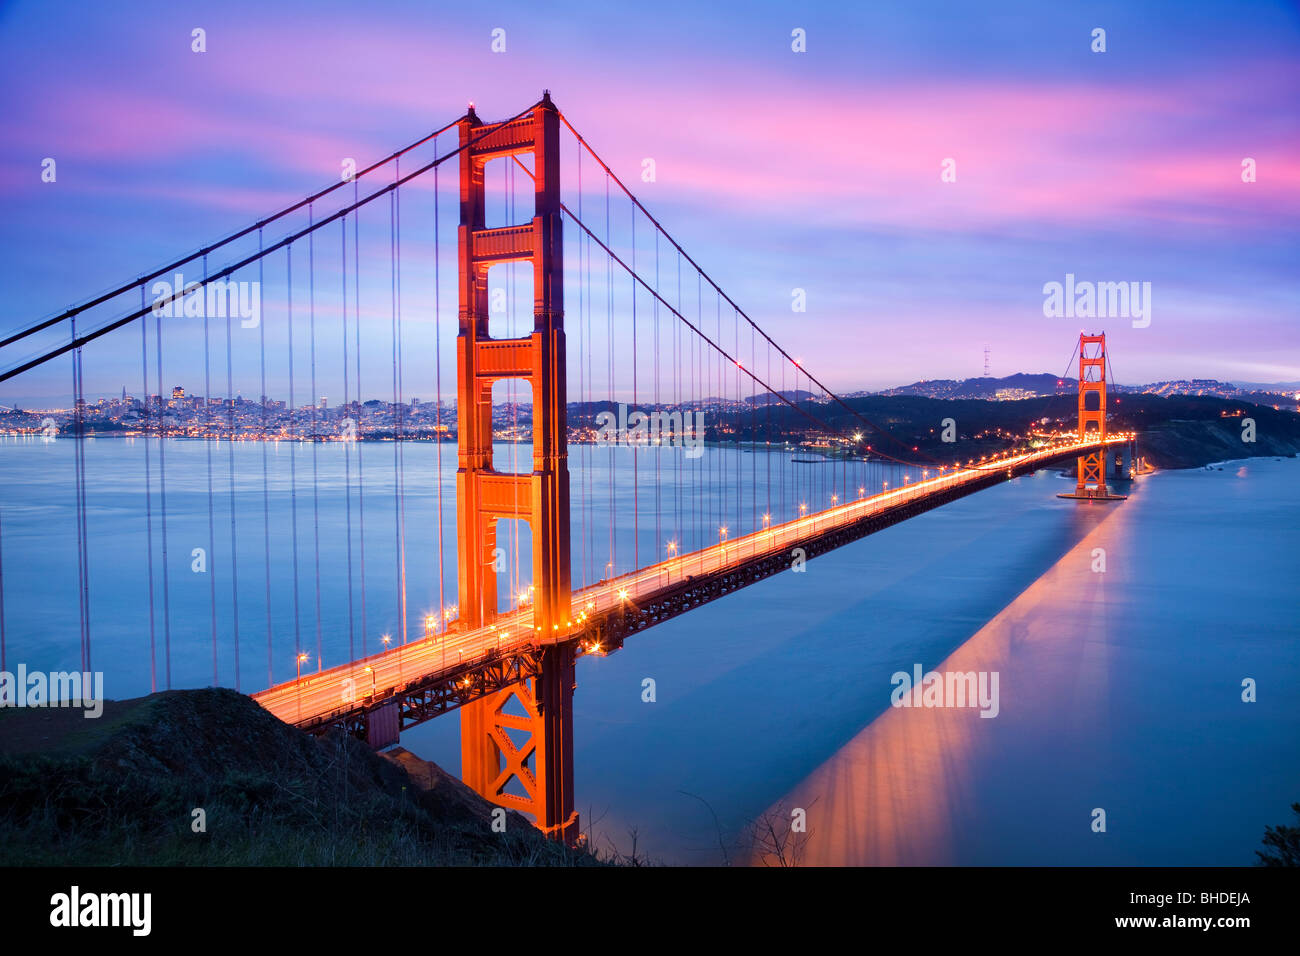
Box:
[0,440,1300,865]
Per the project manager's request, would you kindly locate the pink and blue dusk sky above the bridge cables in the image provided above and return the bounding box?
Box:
[0,0,1300,403]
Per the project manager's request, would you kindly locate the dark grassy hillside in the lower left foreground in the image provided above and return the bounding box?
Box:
[0,688,595,866]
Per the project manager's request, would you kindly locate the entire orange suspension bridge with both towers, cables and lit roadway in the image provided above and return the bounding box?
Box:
[0,94,1132,840]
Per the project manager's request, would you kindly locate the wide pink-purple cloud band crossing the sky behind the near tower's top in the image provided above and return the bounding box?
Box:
[12,12,1300,239]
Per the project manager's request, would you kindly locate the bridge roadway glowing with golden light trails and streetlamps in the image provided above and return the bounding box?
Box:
[254,436,1131,731]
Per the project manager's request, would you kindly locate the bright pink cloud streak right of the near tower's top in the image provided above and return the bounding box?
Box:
[574,73,1300,234]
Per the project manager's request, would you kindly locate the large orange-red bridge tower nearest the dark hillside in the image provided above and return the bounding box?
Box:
[456,92,577,842]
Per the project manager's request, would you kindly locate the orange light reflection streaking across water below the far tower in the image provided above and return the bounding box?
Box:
[754,494,1126,865]
